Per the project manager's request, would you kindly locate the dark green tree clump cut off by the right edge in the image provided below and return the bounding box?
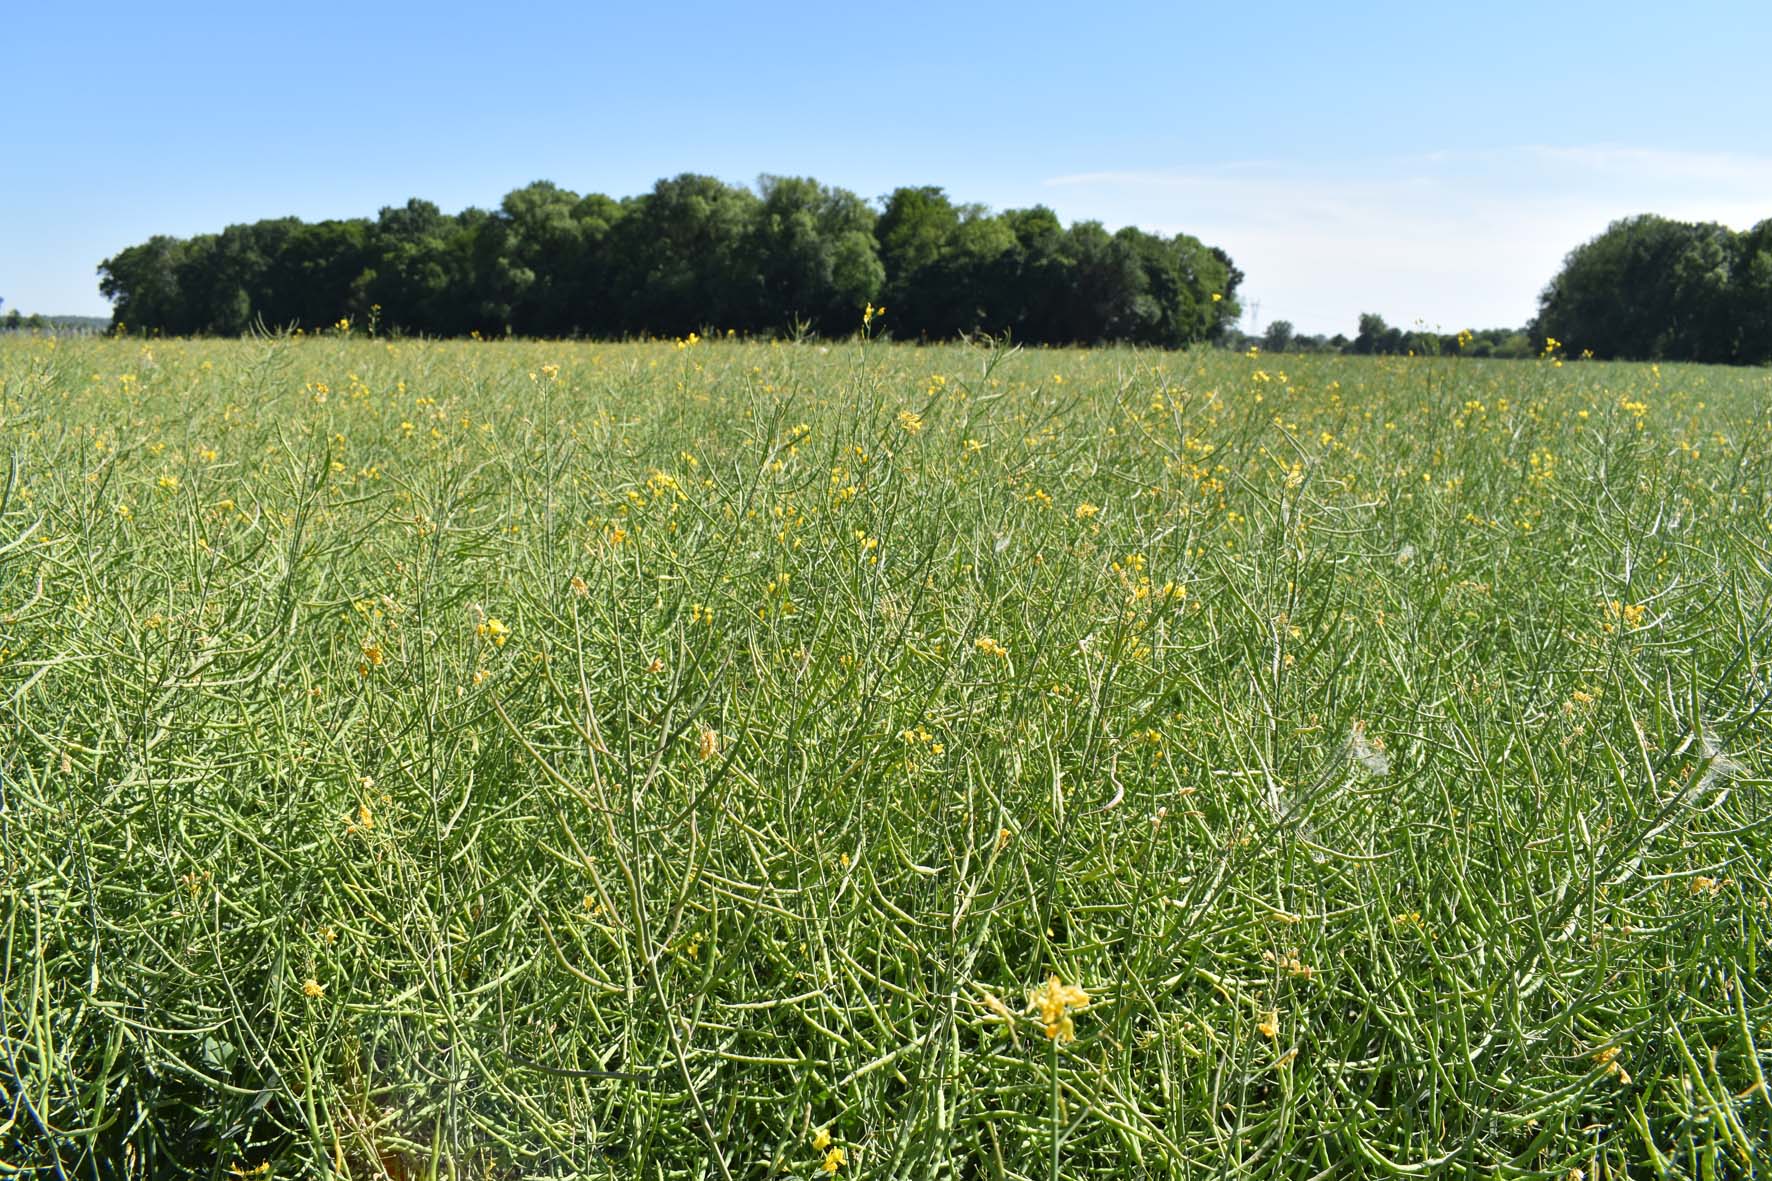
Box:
[1533,215,1772,364]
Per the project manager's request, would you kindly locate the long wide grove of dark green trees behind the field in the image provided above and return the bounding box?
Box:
[89,174,1242,348]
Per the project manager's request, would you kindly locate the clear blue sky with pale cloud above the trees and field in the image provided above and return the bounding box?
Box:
[0,0,1772,333]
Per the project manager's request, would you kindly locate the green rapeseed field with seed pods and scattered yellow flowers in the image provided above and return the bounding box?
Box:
[0,337,1772,1181]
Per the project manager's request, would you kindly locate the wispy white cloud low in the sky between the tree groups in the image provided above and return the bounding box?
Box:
[1042,144,1772,333]
